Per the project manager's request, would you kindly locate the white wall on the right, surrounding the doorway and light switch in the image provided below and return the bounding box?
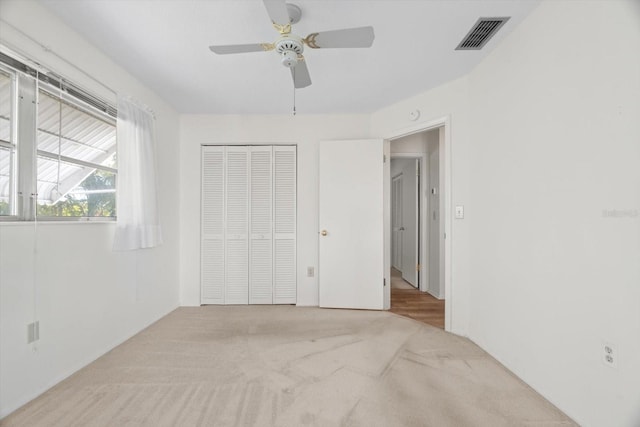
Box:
[372,0,640,426]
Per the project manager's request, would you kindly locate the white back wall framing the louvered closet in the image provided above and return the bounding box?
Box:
[180,115,369,306]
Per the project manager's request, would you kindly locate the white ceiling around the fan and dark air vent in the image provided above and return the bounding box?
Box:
[40,0,539,114]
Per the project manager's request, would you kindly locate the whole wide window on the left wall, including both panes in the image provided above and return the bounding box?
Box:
[0,53,117,220]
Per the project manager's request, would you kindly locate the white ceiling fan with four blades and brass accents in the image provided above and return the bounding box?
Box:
[209,0,374,89]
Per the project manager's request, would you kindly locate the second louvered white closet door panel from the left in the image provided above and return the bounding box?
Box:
[225,147,249,304]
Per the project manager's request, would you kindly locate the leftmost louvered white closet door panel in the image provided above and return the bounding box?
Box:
[205,147,225,304]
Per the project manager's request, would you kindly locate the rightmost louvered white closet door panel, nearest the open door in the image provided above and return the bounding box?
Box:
[273,146,296,304]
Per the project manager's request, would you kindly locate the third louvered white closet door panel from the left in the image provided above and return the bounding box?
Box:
[249,146,273,304]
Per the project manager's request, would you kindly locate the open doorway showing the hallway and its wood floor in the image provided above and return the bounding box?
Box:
[389,126,446,328]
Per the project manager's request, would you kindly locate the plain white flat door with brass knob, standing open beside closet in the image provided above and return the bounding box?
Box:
[319,139,385,310]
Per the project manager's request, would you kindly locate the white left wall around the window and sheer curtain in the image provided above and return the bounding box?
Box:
[0,1,179,417]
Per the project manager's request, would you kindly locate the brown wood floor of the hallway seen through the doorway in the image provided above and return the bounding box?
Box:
[390,269,444,329]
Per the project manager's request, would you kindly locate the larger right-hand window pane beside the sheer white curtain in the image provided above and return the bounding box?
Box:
[36,89,116,217]
